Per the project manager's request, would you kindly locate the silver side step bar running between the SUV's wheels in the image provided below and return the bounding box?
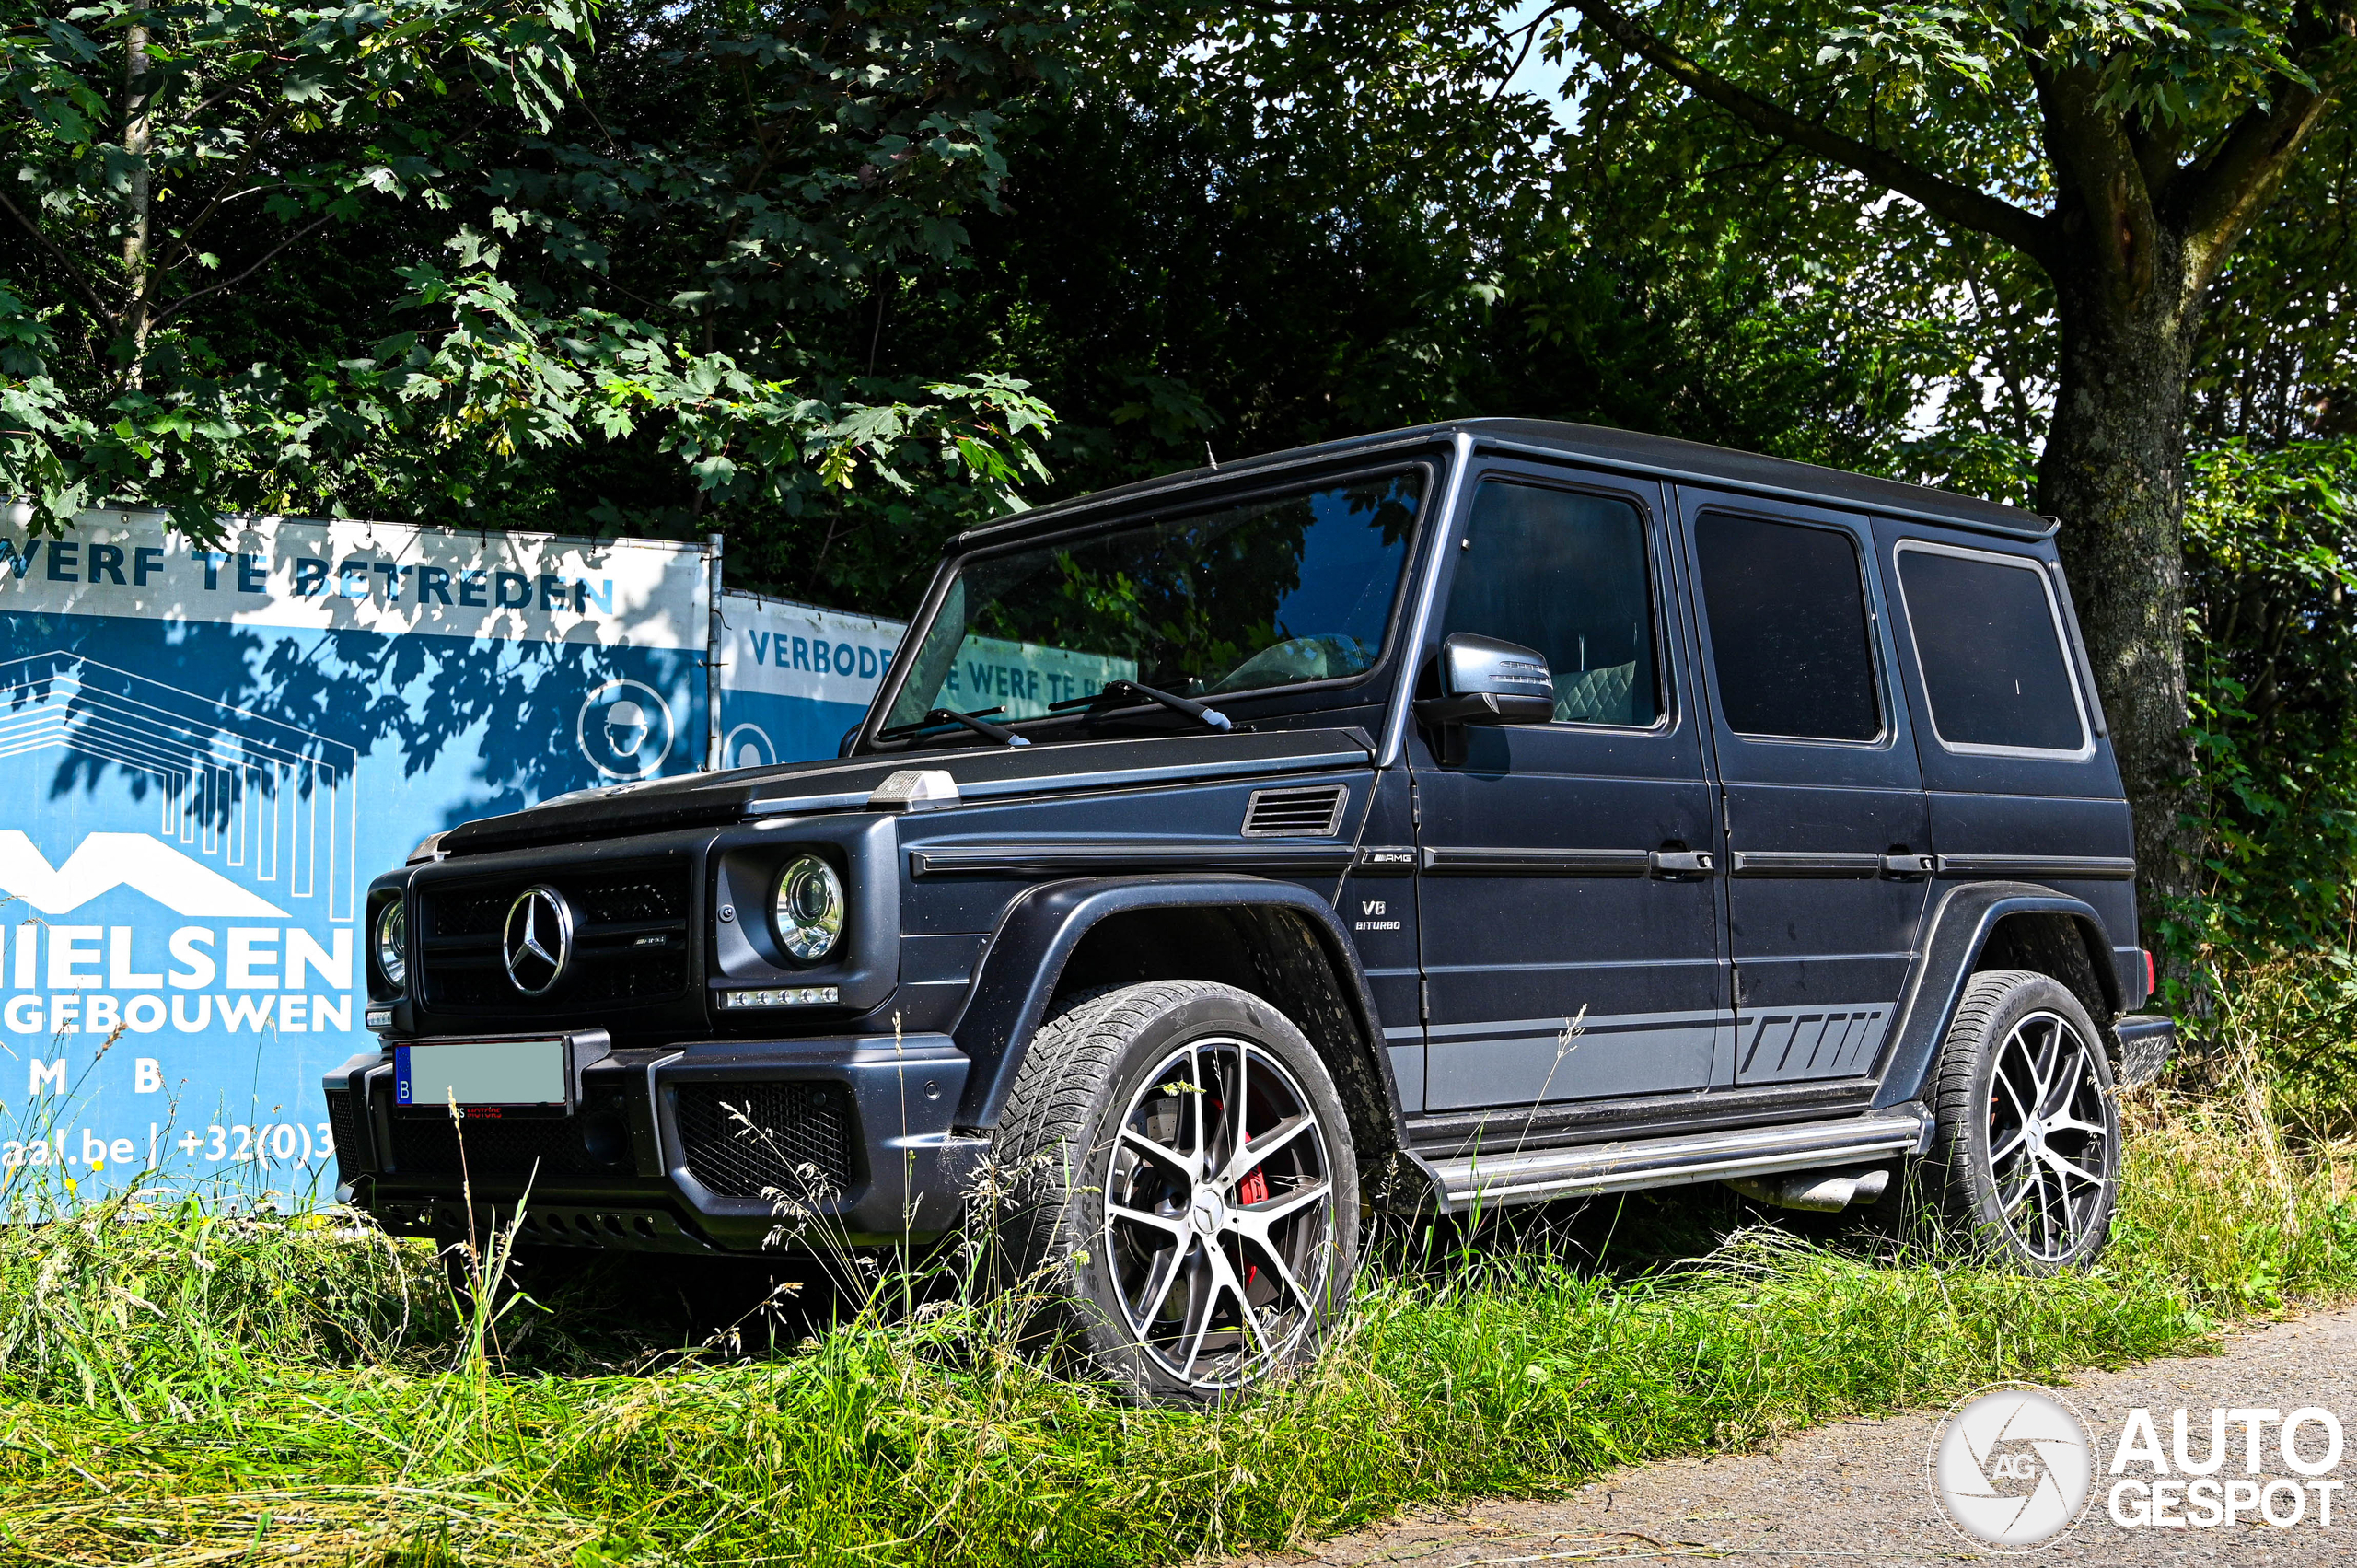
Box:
[1410,1104,1931,1214]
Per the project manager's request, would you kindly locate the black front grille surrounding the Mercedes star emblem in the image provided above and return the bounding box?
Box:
[417,858,693,1014]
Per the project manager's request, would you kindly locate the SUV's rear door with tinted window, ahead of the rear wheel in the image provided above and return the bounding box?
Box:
[1678,486,1931,1085]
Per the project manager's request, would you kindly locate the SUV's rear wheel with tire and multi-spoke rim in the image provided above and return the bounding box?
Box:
[1895,970,2119,1273]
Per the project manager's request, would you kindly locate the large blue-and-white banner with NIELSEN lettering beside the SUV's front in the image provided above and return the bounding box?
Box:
[0,512,712,1198]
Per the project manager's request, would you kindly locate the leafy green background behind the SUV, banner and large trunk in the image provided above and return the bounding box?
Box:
[14,0,2357,971]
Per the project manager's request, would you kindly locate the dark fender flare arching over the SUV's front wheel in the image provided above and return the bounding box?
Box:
[950,875,1400,1127]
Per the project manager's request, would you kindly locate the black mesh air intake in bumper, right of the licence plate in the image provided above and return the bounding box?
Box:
[679,1082,853,1205]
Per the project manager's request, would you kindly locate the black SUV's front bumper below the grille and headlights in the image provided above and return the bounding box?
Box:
[328,1035,990,1252]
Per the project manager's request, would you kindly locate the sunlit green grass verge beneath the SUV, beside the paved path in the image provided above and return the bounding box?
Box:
[0,1032,2357,1568]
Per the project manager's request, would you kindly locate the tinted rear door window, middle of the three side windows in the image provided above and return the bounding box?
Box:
[1695,512,1883,740]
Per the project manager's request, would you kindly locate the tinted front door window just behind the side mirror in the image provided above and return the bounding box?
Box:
[1443,481,1662,728]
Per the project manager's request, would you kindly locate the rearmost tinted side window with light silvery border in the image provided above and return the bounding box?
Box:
[1899,545,2086,752]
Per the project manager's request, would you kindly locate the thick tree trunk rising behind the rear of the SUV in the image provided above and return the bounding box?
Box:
[2038,236,2201,946]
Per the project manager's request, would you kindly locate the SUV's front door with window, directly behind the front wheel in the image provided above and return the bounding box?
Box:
[1410,464,1730,1115]
